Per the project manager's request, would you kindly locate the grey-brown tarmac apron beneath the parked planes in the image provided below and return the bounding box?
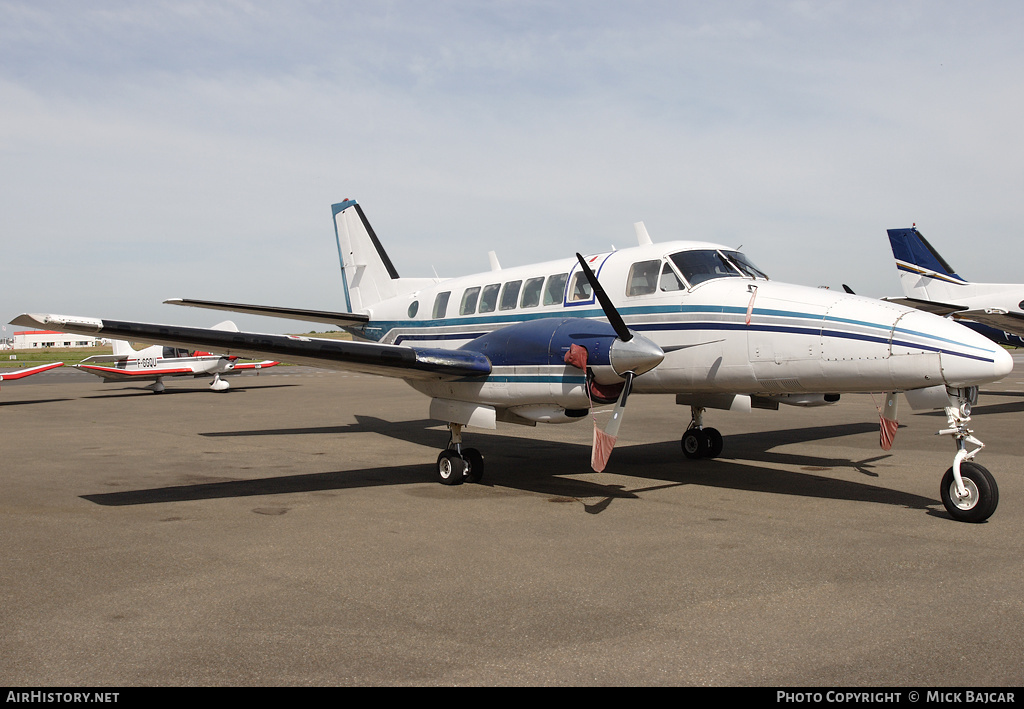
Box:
[0,355,1024,689]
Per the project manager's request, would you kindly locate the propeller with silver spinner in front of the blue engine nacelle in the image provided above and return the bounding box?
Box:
[577,253,665,472]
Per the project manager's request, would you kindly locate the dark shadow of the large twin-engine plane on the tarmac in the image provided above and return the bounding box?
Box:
[82,416,940,513]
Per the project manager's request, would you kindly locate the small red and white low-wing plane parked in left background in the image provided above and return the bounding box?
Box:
[72,331,279,393]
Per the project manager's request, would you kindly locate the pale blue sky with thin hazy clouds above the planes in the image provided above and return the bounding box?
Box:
[0,0,1024,332]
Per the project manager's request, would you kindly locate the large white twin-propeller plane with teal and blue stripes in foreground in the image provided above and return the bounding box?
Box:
[12,201,1013,522]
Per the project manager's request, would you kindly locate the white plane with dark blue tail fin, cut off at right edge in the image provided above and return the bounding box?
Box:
[886,226,1024,347]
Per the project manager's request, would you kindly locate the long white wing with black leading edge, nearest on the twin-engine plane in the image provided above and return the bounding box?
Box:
[11,314,490,379]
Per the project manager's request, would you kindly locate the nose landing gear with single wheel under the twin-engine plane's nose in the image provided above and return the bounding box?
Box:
[939,386,999,523]
